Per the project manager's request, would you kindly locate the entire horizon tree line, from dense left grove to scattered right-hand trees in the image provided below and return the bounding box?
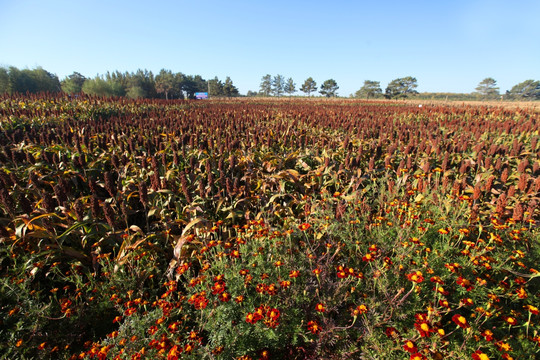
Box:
[0,66,540,100]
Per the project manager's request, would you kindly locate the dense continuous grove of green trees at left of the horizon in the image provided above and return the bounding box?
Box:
[0,66,240,99]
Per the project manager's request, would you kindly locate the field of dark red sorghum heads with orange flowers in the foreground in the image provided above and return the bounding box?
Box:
[0,95,540,360]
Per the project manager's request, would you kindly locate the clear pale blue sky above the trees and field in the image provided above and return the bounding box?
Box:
[0,0,540,96]
